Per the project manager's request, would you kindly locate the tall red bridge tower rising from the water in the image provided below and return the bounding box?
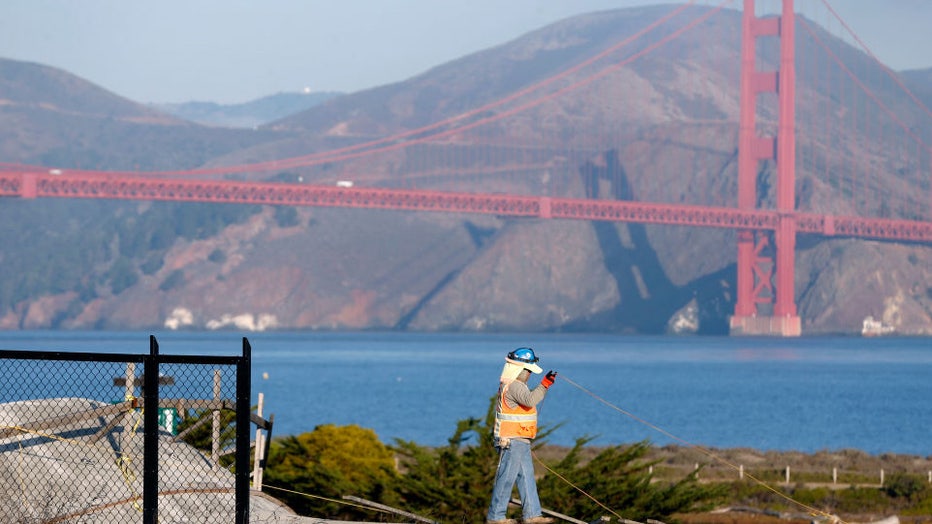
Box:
[731,0,801,336]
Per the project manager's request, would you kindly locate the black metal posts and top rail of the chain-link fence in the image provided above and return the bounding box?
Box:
[0,335,253,524]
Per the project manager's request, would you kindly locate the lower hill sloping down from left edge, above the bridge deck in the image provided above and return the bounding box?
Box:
[0,59,288,170]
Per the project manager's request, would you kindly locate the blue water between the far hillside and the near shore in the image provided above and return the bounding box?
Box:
[0,331,932,456]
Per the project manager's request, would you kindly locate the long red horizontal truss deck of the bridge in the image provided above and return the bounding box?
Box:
[0,170,932,243]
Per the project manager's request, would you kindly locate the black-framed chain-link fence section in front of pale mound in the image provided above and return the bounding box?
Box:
[0,336,251,524]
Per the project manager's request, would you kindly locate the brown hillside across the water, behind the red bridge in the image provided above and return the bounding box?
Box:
[0,7,932,334]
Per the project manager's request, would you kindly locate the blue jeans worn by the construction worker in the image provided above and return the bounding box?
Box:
[486,440,541,520]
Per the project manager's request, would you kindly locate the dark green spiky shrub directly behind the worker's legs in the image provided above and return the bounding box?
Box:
[396,398,727,522]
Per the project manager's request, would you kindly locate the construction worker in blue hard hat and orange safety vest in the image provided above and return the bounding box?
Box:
[486,347,557,524]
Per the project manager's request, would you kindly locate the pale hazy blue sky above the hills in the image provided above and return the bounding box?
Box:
[0,0,932,103]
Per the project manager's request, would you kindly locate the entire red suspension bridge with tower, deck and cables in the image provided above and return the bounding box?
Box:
[0,0,932,336]
